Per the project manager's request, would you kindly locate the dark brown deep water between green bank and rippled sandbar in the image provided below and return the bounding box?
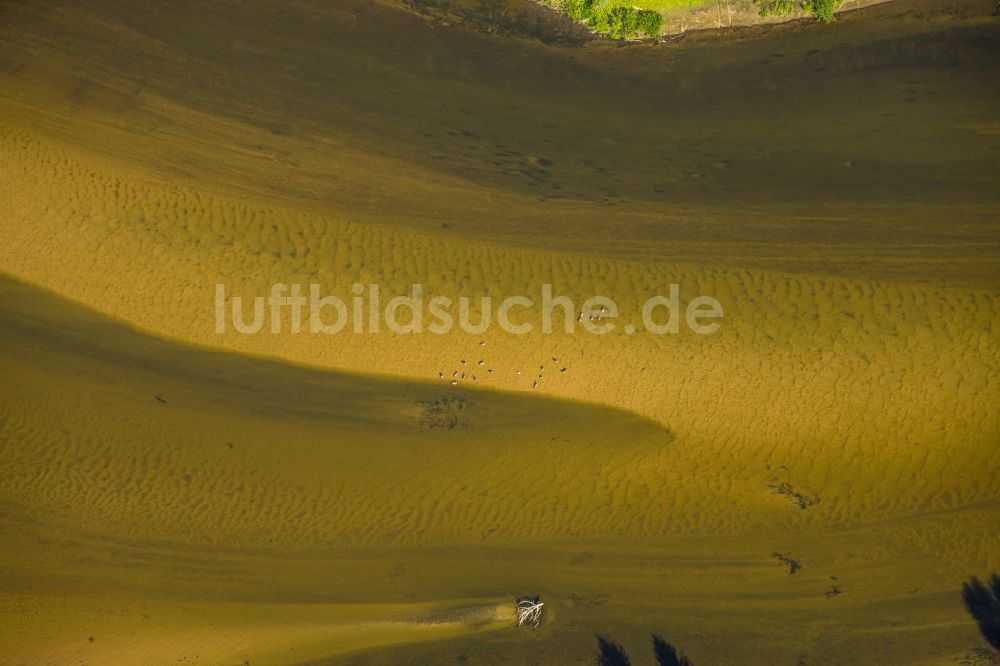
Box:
[0,0,1000,287]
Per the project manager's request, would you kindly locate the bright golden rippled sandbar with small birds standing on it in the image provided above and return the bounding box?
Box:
[0,129,1000,541]
